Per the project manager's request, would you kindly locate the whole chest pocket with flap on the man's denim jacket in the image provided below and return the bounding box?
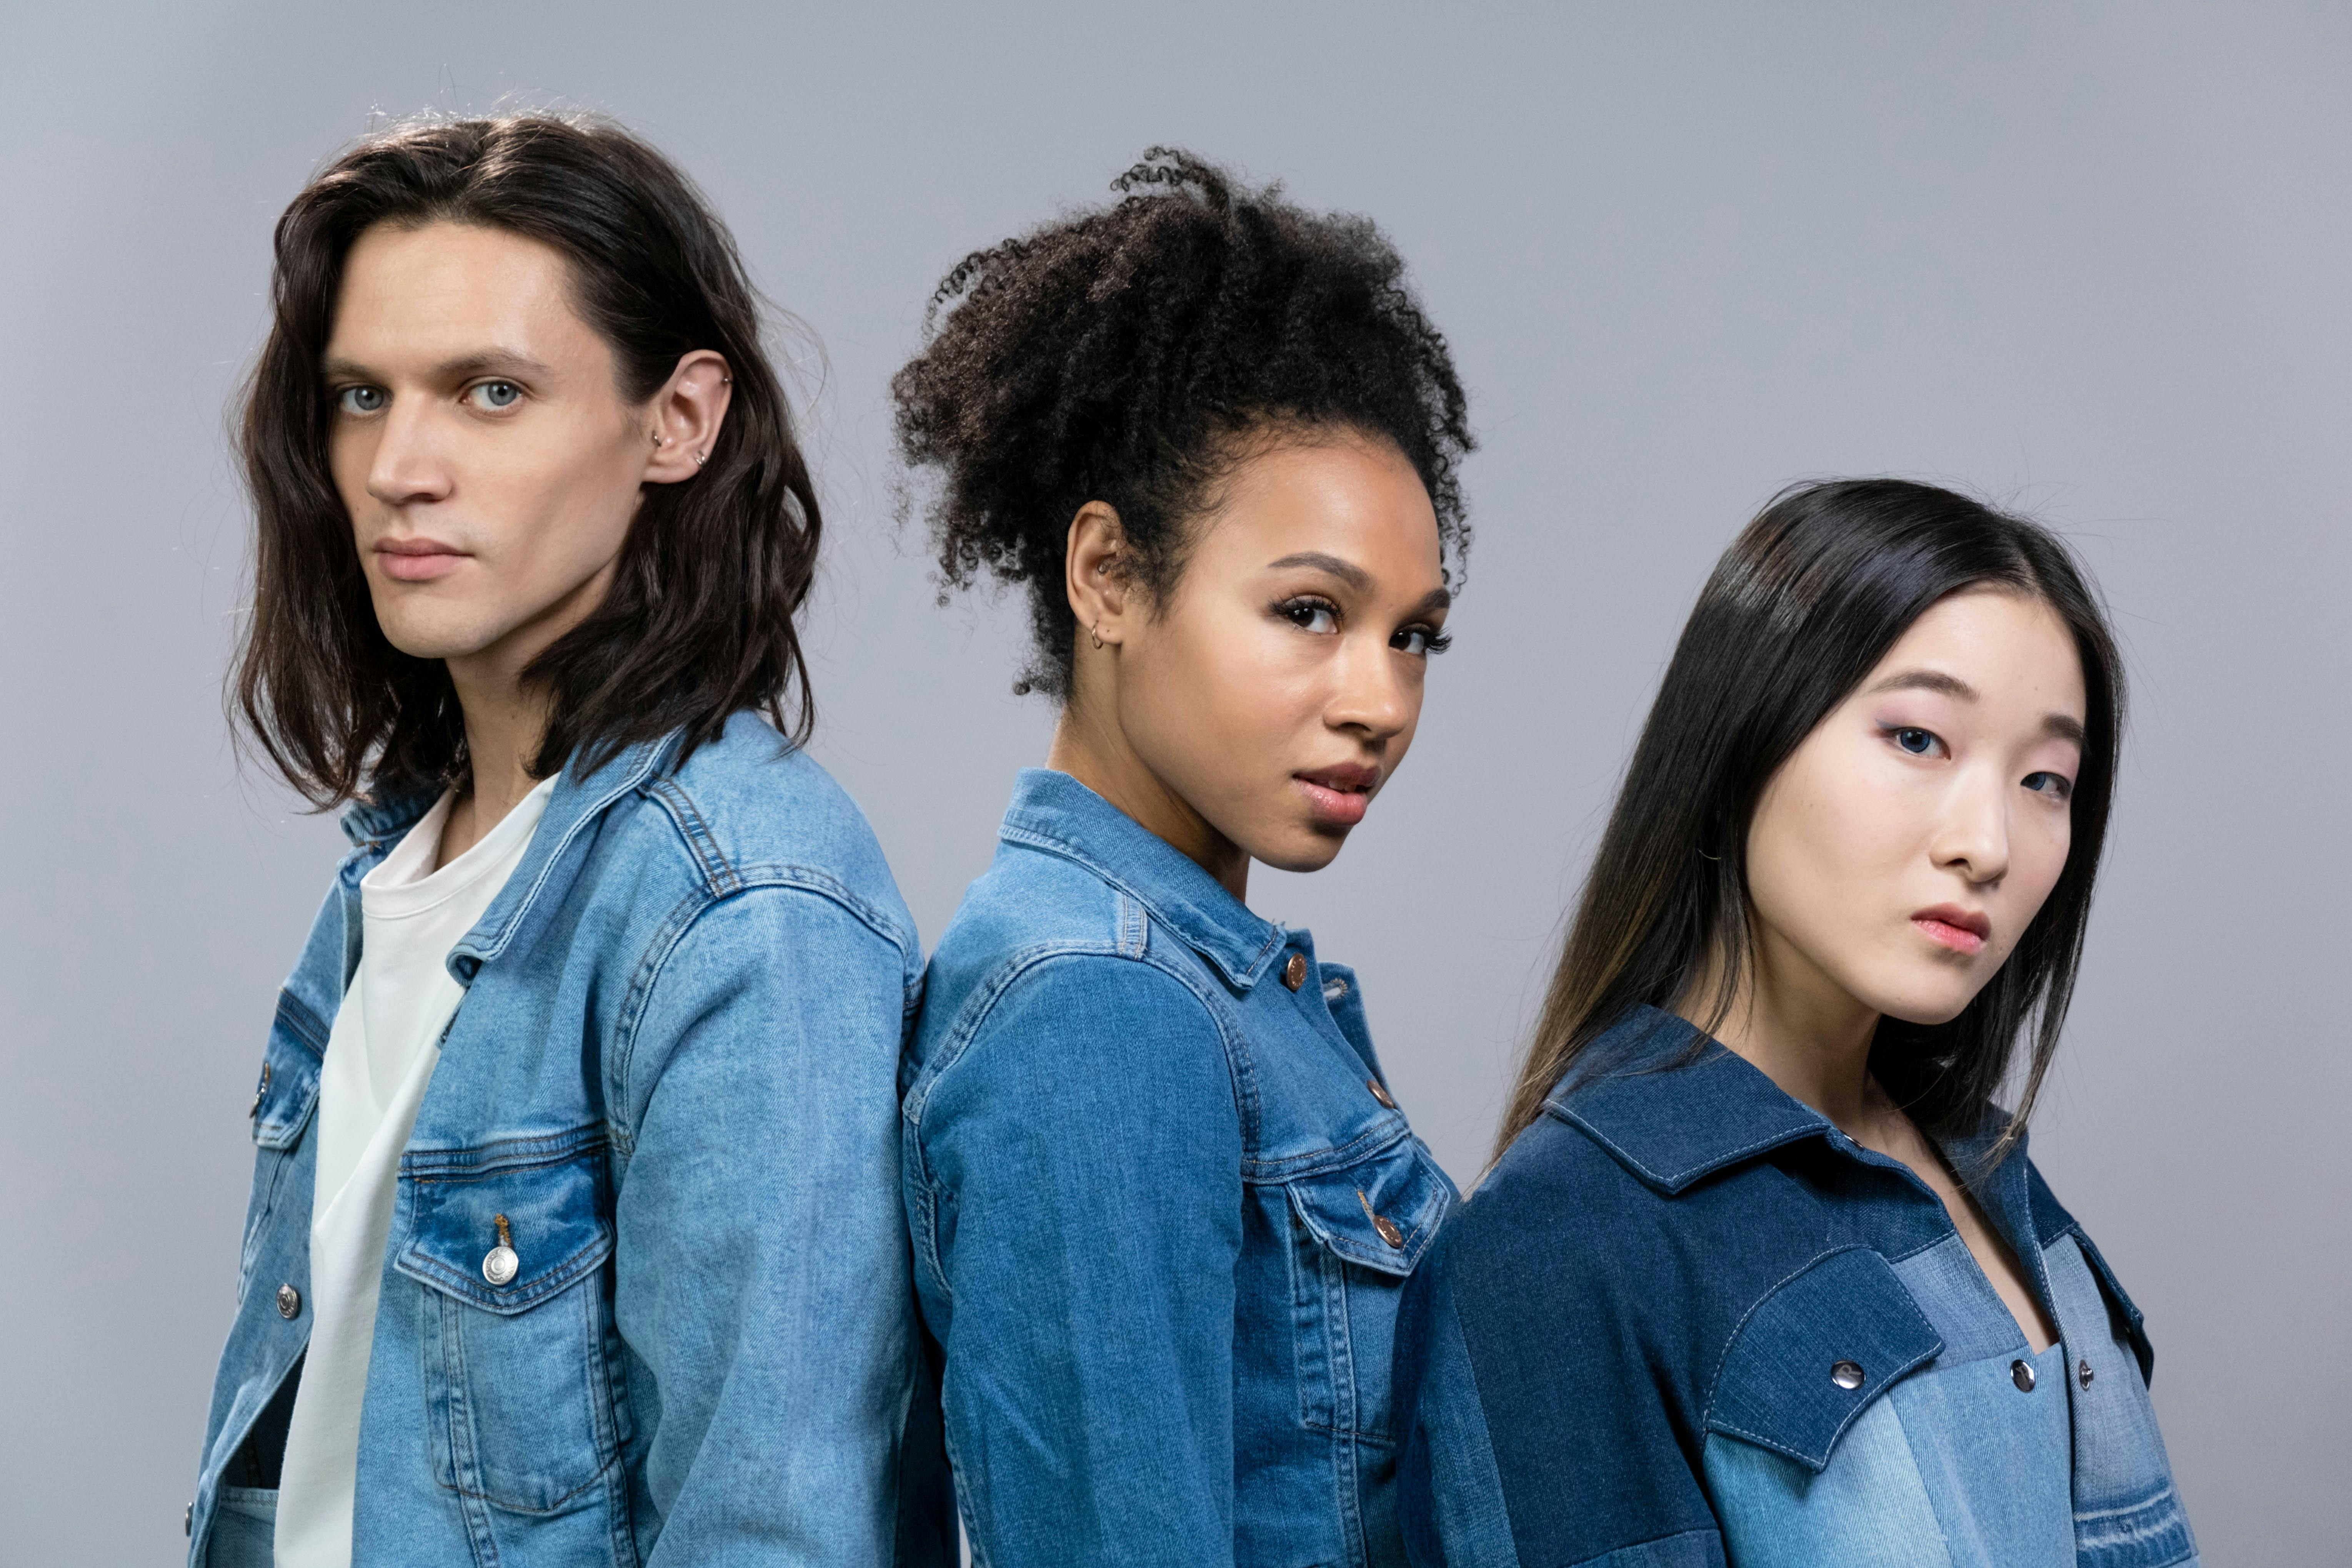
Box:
[393,1126,626,1514]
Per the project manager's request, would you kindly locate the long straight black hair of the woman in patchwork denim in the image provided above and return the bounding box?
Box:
[1496,480,2124,1161]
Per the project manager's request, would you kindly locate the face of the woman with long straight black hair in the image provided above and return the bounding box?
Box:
[1747,588,2086,1023]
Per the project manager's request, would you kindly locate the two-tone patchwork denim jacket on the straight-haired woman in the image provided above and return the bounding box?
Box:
[1397,1008,2197,1568]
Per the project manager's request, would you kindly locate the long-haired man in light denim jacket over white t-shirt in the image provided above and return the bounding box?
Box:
[188,115,941,1568]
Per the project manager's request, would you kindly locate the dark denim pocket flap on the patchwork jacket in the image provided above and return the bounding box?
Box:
[1707,1246,1943,1474]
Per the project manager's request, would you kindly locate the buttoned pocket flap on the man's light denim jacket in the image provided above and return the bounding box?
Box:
[393,1126,611,1314]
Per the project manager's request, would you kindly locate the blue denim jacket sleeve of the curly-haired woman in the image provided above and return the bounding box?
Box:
[913,955,1242,1568]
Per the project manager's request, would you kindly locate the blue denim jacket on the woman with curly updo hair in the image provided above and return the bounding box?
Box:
[903,769,1454,1568]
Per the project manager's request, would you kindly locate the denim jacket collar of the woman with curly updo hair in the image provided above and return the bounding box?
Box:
[992,769,1284,992]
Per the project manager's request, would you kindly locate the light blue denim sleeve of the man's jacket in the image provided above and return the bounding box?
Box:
[609,886,913,1568]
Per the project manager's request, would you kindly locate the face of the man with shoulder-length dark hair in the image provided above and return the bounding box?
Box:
[322,223,658,679]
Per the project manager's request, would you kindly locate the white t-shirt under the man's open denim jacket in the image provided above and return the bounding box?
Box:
[278,778,555,1568]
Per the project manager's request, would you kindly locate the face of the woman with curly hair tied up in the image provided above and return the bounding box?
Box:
[1117,435,1449,872]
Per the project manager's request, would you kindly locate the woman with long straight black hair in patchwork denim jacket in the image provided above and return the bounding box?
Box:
[1397,480,2197,1568]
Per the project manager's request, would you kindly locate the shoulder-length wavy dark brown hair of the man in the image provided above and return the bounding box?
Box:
[233,115,821,809]
